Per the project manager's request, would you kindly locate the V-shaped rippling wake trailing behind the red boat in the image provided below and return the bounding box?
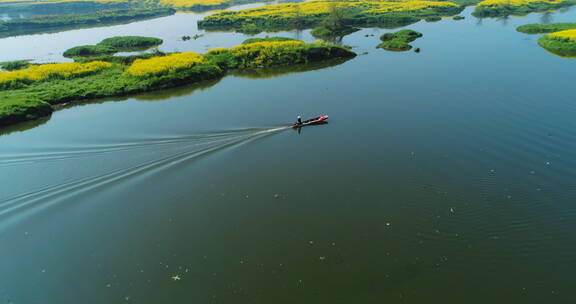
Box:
[0,127,290,228]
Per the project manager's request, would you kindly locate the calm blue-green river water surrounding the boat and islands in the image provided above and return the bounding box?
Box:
[0,4,576,304]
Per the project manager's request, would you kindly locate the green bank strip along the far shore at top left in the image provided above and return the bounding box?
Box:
[0,8,176,37]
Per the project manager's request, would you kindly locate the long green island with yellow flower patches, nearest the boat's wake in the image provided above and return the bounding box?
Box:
[0,38,356,126]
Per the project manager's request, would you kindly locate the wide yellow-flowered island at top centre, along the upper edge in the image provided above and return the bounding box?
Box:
[198,0,463,31]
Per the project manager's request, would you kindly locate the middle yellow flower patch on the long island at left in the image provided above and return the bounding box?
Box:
[126,52,204,76]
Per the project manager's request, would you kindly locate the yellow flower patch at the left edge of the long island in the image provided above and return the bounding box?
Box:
[0,61,112,83]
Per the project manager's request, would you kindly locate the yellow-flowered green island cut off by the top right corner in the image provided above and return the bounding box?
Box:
[472,0,576,18]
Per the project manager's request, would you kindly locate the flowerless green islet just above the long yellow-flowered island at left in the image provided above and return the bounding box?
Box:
[63,36,163,58]
